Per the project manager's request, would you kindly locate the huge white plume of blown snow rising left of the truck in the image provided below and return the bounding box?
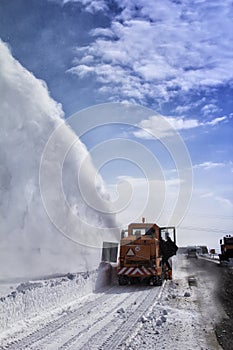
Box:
[0,41,118,279]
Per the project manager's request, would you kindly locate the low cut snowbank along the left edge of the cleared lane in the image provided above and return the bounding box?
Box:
[0,271,99,333]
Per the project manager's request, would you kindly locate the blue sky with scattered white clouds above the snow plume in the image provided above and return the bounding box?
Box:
[0,0,233,249]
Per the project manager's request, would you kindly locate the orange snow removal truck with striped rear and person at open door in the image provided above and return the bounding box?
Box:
[117,220,178,285]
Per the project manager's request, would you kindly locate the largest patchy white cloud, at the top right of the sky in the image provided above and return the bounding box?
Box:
[68,0,233,104]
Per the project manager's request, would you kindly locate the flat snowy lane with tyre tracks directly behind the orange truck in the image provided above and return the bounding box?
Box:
[1,286,161,350]
